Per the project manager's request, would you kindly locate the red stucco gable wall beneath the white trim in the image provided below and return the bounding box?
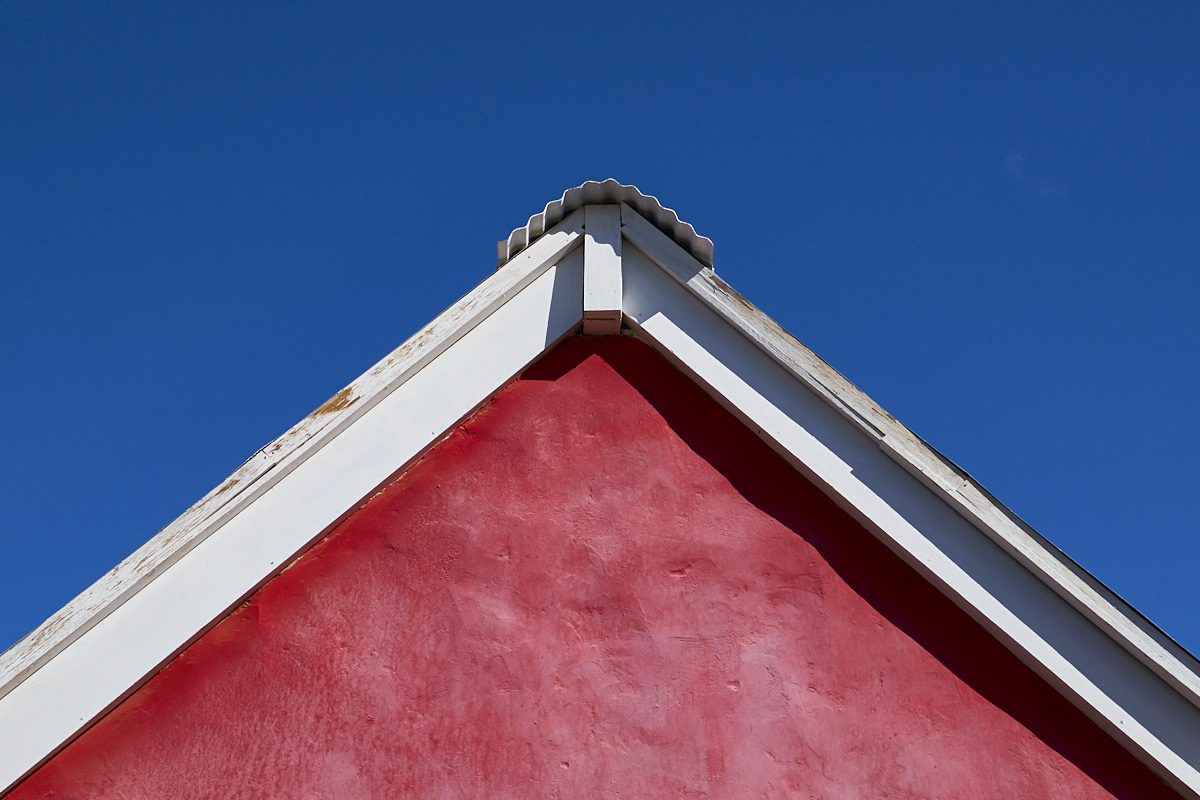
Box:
[11,338,1175,800]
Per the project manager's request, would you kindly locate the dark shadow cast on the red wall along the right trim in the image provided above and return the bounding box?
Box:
[522,337,1178,800]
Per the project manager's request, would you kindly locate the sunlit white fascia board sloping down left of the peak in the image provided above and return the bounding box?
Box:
[0,211,583,794]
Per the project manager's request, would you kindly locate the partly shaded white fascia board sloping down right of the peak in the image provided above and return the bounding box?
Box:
[622,217,1200,798]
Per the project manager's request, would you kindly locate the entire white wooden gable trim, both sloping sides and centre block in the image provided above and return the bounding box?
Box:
[0,190,1200,798]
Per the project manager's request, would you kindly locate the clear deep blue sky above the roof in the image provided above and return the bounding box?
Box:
[0,2,1200,651]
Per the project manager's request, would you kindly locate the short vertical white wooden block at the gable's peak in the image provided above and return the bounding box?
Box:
[583,205,620,336]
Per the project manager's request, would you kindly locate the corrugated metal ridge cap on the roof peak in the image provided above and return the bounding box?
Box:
[497,178,713,267]
